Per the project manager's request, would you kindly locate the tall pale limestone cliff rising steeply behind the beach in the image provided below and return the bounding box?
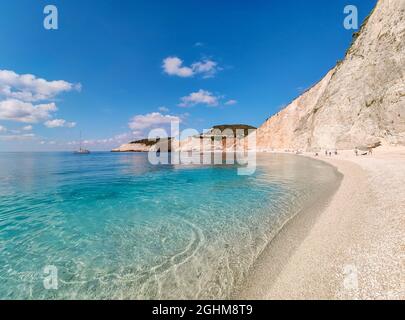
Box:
[257,0,405,150]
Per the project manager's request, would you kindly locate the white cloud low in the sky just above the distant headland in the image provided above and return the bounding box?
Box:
[129,112,181,135]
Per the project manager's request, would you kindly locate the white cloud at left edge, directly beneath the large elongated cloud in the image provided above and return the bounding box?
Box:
[0,99,57,123]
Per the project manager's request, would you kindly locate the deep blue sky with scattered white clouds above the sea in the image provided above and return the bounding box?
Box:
[0,0,376,151]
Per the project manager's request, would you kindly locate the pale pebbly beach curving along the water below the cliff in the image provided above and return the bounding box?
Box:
[235,148,405,299]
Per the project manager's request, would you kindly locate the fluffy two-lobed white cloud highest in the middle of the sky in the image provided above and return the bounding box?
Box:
[163,57,220,78]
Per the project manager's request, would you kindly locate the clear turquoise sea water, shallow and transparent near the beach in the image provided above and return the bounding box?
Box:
[0,153,339,299]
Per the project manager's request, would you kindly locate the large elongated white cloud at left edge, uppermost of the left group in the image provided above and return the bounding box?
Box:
[0,70,81,102]
